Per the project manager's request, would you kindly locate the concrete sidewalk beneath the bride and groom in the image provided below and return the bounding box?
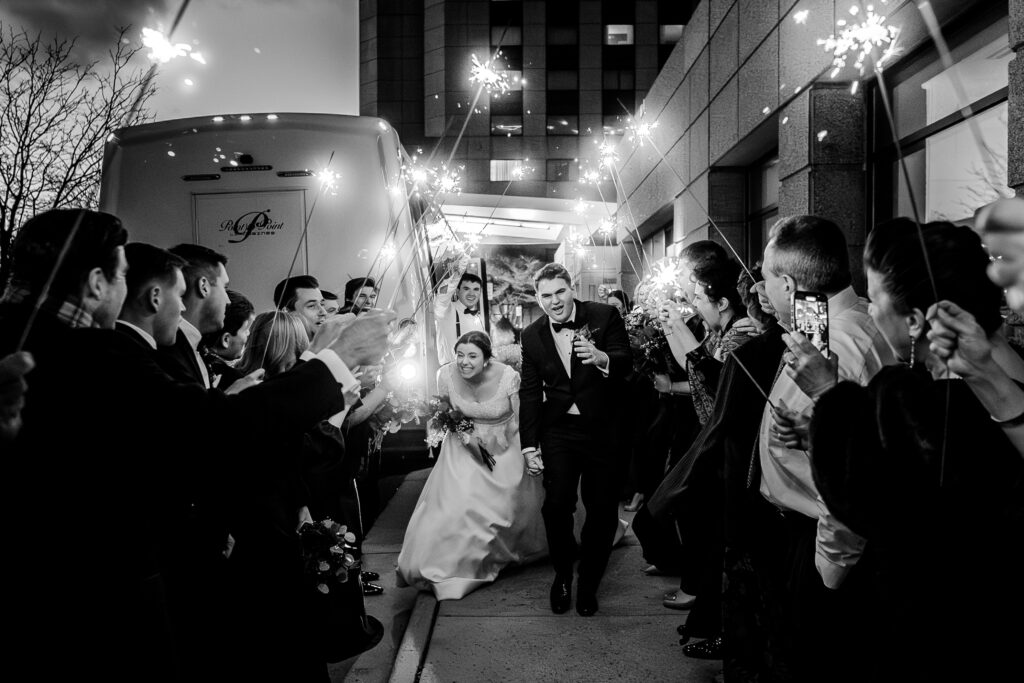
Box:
[332,471,721,683]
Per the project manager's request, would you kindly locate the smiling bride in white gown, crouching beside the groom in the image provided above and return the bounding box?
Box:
[397,332,548,600]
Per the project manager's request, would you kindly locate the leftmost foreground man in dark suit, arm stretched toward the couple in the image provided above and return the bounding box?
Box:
[0,209,395,681]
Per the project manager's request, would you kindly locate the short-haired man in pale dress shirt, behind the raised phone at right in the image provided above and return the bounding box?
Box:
[749,216,893,680]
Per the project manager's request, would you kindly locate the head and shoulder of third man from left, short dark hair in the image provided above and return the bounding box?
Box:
[159,244,228,389]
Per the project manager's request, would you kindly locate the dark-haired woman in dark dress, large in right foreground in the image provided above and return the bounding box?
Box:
[804,219,1024,680]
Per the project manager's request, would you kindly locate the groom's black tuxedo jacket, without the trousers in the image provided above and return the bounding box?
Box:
[519,301,633,449]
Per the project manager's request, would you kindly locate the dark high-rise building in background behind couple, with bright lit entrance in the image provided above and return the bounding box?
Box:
[359,0,697,278]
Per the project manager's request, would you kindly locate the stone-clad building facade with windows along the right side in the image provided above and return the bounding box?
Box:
[617,0,1024,294]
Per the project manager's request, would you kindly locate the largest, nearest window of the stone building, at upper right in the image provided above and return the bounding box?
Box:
[872,15,1014,222]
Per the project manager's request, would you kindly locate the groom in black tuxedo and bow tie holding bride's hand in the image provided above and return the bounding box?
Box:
[519,263,632,616]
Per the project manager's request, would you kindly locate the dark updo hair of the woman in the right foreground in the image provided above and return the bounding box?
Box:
[864,218,1002,335]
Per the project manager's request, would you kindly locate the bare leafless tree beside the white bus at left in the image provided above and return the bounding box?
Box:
[0,23,155,285]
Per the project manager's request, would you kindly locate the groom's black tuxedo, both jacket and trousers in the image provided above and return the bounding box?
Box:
[519,301,632,593]
